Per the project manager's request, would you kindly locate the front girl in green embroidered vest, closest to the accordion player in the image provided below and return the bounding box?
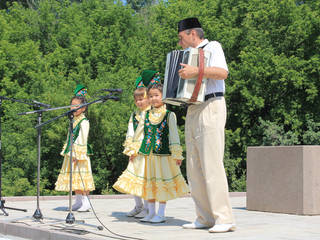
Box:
[139,82,189,223]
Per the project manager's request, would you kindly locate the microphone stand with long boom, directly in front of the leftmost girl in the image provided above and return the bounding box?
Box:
[22,93,119,230]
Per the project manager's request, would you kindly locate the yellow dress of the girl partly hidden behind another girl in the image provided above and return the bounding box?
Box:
[113,107,150,196]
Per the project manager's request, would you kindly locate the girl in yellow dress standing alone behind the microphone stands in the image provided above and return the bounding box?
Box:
[55,96,95,212]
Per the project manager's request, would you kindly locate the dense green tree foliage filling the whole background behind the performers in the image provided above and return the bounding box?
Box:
[0,0,320,195]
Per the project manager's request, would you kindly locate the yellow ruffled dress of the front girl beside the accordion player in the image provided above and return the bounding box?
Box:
[141,105,189,202]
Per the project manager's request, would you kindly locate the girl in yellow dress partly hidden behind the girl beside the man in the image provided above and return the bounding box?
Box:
[113,70,156,218]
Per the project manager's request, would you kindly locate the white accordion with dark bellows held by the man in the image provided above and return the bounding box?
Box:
[162,48,211,106]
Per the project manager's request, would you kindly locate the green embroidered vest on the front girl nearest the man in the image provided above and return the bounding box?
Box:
[139,110,171,155]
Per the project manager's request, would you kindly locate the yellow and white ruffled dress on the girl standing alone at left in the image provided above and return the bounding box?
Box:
[55,114,95,191]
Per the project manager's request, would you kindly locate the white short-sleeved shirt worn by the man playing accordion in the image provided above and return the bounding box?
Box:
[197,39,229,95]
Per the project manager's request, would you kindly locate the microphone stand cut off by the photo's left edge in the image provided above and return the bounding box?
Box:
[0,96,33,216]
